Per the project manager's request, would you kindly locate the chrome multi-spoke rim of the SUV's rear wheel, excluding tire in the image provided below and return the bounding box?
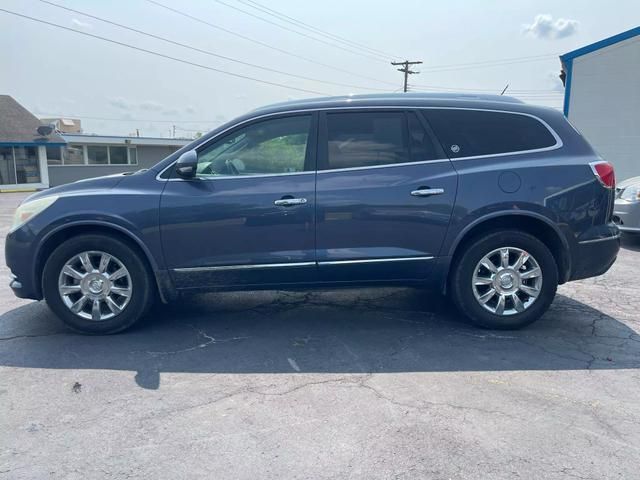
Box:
[472,247,542,316]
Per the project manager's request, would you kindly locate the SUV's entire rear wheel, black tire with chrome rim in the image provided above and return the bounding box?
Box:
[450,230,558,330]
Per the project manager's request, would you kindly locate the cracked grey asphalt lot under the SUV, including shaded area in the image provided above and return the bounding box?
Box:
[0,194,640,479]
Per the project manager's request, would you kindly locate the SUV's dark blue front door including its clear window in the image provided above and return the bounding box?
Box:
[160,114,317,288]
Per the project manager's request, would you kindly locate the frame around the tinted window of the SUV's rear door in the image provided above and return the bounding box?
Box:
[317,106,449,173]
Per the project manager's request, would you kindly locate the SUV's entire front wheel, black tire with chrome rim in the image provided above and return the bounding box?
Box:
[42,234,154,335]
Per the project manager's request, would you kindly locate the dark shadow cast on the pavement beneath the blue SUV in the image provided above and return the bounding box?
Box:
[0,289,640,389]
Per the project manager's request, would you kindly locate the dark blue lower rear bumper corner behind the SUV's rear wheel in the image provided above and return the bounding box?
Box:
[570,232,620,280]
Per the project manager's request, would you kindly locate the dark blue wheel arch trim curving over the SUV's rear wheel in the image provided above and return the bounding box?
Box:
[447,211,571,284]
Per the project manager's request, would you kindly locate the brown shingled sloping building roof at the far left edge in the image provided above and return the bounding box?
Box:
[0,95,65,145]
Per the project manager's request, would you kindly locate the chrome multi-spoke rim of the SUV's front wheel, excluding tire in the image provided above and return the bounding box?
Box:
[58,251,133,322]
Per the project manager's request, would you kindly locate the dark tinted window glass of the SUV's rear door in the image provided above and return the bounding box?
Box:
[321,111,437,170]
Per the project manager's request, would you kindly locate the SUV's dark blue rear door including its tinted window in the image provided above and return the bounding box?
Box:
[316,109,457,282]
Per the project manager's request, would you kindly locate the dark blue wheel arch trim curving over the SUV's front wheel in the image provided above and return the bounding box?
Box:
[34,221,172,303]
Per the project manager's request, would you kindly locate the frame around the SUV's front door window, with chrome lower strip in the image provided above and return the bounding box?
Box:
[181,110,318,181]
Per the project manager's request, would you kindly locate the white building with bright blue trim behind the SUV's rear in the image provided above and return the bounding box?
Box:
[560,27,640,180]
